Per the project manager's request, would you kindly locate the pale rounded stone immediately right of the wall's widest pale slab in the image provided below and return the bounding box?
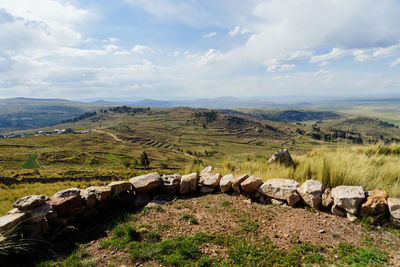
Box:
[297,180,325,208]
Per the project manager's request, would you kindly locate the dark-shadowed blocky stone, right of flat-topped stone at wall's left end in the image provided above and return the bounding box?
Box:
[48,195,85,217]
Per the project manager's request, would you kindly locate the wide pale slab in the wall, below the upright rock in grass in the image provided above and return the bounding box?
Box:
[258,178,299,200]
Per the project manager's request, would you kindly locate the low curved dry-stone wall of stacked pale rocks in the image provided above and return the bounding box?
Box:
[0,162,400,244]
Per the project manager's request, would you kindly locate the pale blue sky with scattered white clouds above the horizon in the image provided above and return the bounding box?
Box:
[0,0,400,100]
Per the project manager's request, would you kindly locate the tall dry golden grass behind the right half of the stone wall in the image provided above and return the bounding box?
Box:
[216,145,400,197]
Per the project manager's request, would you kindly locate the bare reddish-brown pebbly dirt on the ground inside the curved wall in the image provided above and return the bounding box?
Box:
[76,194,400,266]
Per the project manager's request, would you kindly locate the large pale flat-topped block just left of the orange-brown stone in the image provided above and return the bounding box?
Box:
[332,185,365,214]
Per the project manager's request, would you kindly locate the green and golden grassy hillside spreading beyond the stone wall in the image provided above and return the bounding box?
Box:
[0,108,400,214]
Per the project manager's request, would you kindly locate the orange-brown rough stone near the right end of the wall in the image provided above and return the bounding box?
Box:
[360,188,388,216]
